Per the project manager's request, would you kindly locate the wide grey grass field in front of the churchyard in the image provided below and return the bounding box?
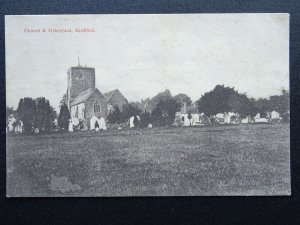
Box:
[7,124,290,196]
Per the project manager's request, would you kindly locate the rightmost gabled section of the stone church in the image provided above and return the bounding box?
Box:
[104,89,128,113]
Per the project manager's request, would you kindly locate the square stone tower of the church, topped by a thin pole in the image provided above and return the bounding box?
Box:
[67,65,95,109]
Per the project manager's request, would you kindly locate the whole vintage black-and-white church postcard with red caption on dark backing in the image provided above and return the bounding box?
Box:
[5,13,291,197]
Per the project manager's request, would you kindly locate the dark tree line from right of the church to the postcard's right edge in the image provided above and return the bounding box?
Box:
[108,85,289,126]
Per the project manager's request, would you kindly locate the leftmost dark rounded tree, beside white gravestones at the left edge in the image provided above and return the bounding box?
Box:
[17,98,36,134]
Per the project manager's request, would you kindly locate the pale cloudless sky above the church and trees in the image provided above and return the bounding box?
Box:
[5,14,289,109]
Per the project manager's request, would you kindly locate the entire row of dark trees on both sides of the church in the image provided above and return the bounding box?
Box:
[6,85,289,133]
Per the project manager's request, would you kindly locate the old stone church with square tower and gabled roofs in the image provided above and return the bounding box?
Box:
[67,63,128,125]
